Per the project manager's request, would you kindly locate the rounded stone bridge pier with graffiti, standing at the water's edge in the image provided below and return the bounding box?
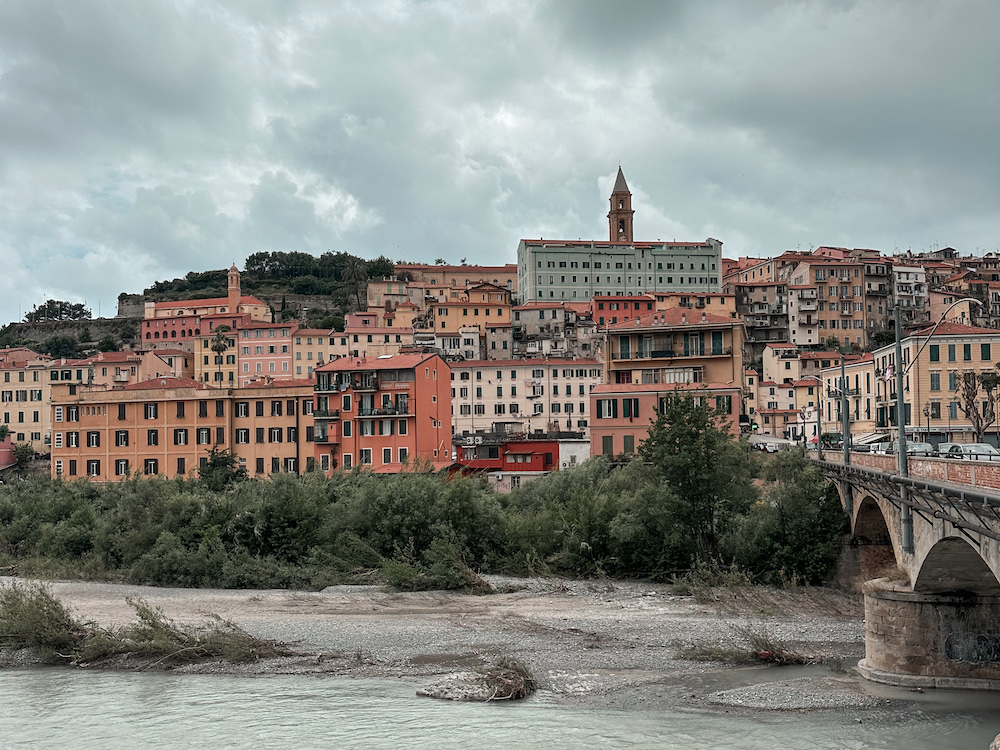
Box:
[858,578,1000,690]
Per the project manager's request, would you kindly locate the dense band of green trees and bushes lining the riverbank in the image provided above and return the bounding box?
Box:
[0,398,845,588]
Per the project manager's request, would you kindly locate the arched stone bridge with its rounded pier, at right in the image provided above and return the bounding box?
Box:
[818,453,1000,690]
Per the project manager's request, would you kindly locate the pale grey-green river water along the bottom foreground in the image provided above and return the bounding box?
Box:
[0,669,1000,750]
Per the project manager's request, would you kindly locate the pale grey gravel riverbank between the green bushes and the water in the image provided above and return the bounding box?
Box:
[0,578,900,710]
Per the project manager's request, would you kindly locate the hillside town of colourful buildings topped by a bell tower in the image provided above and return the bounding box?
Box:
[0,170,1000,484]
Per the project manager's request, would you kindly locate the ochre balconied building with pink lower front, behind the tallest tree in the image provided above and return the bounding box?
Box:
[590,308,759,456]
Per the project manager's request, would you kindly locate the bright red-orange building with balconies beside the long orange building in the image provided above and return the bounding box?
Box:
[313,354,451,473]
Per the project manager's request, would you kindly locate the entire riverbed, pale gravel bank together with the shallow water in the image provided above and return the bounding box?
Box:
[0,578,1000,748]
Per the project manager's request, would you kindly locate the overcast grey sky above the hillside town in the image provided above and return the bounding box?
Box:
[0,0,1000,323]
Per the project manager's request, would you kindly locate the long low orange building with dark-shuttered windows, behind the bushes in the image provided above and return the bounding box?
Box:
[51,378,314,482]
